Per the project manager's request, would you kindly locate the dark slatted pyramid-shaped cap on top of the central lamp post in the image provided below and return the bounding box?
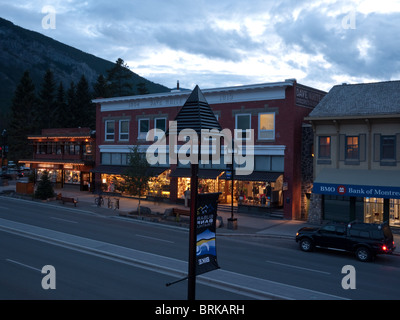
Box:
[169,85,222,136]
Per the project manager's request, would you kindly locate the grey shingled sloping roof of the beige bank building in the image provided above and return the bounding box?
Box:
[307,81,400,120]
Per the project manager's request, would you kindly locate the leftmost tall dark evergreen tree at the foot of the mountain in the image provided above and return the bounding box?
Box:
[8,71,38,162]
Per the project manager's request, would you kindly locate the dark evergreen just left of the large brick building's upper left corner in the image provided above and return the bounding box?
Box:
[75,75,96,129]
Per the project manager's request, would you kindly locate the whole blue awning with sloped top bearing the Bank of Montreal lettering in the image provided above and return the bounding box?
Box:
[313,169,400,199]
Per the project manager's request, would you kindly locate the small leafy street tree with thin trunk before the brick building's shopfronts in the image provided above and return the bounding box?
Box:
[123,145,150,215]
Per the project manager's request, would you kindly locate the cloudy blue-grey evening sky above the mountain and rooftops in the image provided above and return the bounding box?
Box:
[0,0,400,91]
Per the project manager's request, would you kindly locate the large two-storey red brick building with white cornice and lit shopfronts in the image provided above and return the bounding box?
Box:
[93,79,326,219]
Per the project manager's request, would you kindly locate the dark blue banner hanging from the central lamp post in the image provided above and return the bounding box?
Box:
[196,193,221,275]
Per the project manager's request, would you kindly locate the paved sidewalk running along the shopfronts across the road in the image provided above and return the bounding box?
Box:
[0,181,400,245]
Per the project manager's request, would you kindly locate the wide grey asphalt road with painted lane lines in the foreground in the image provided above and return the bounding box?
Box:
[0,197,400,300]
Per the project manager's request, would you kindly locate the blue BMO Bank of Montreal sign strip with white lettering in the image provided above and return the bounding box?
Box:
[313,183,400,199]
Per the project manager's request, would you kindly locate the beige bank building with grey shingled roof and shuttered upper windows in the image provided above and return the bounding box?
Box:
[306,81,400,227]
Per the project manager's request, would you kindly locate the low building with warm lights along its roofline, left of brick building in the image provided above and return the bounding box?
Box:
[19,128,96,191]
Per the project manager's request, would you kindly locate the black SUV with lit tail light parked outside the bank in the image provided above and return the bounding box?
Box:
[296,222,396,261]
